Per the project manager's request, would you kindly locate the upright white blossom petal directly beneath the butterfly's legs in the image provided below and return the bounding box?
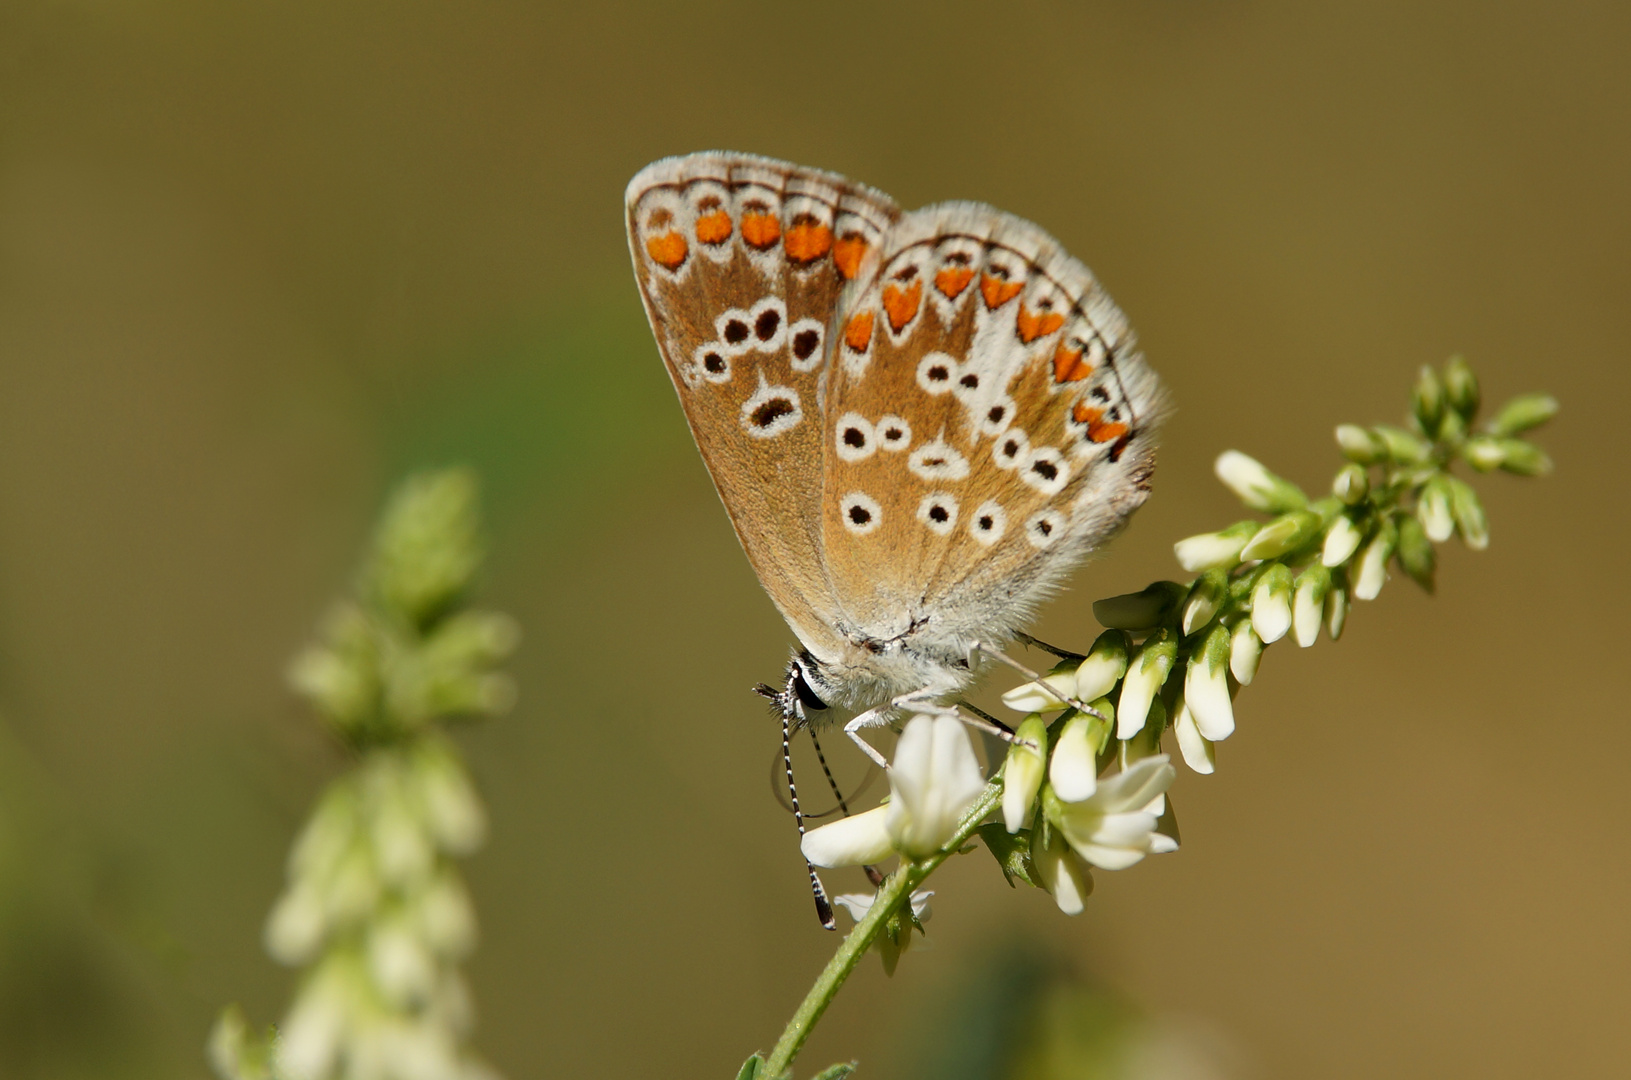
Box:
[884,716,985,858]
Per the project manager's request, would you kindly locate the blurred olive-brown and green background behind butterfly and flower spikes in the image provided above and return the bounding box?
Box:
[0,0,1631,1078]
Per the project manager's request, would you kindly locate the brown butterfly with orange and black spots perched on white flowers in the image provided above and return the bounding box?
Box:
[626,152,1165,904]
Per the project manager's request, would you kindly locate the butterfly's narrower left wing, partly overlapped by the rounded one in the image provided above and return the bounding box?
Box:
[626,153,900,656]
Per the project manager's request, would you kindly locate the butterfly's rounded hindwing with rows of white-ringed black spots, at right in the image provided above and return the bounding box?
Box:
[822,204,1163,654]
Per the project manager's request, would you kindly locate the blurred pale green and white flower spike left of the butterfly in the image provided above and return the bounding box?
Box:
[209,470,517,1080]
